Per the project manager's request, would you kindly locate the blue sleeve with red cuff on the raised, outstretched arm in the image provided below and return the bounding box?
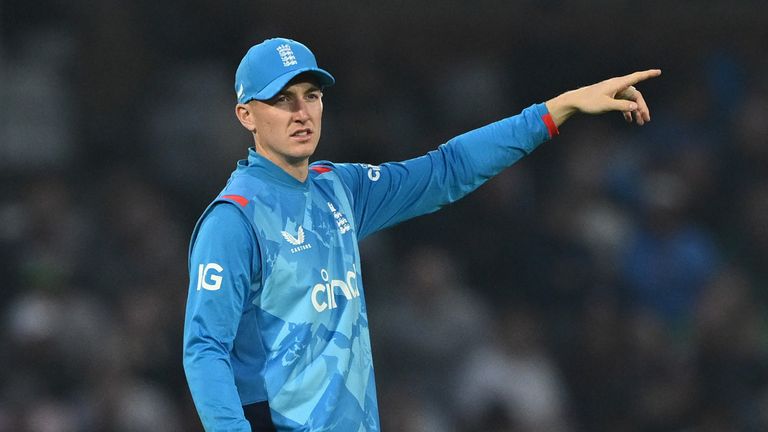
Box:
[334,104,557,239]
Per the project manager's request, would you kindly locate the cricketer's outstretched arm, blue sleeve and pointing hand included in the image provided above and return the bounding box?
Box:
[336,69,661,238]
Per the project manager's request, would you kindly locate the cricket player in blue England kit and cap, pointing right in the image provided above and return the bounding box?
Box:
[184,38,661,432]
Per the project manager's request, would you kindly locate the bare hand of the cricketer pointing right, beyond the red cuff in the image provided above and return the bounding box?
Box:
[546,69,661,127]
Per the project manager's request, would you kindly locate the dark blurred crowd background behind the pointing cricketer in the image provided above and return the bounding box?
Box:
[0,0,768,432]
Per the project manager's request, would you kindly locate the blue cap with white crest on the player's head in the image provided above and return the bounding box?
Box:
[235,38,336,103]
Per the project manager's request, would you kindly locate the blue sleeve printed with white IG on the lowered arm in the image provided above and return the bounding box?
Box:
[184,203,259,432]
